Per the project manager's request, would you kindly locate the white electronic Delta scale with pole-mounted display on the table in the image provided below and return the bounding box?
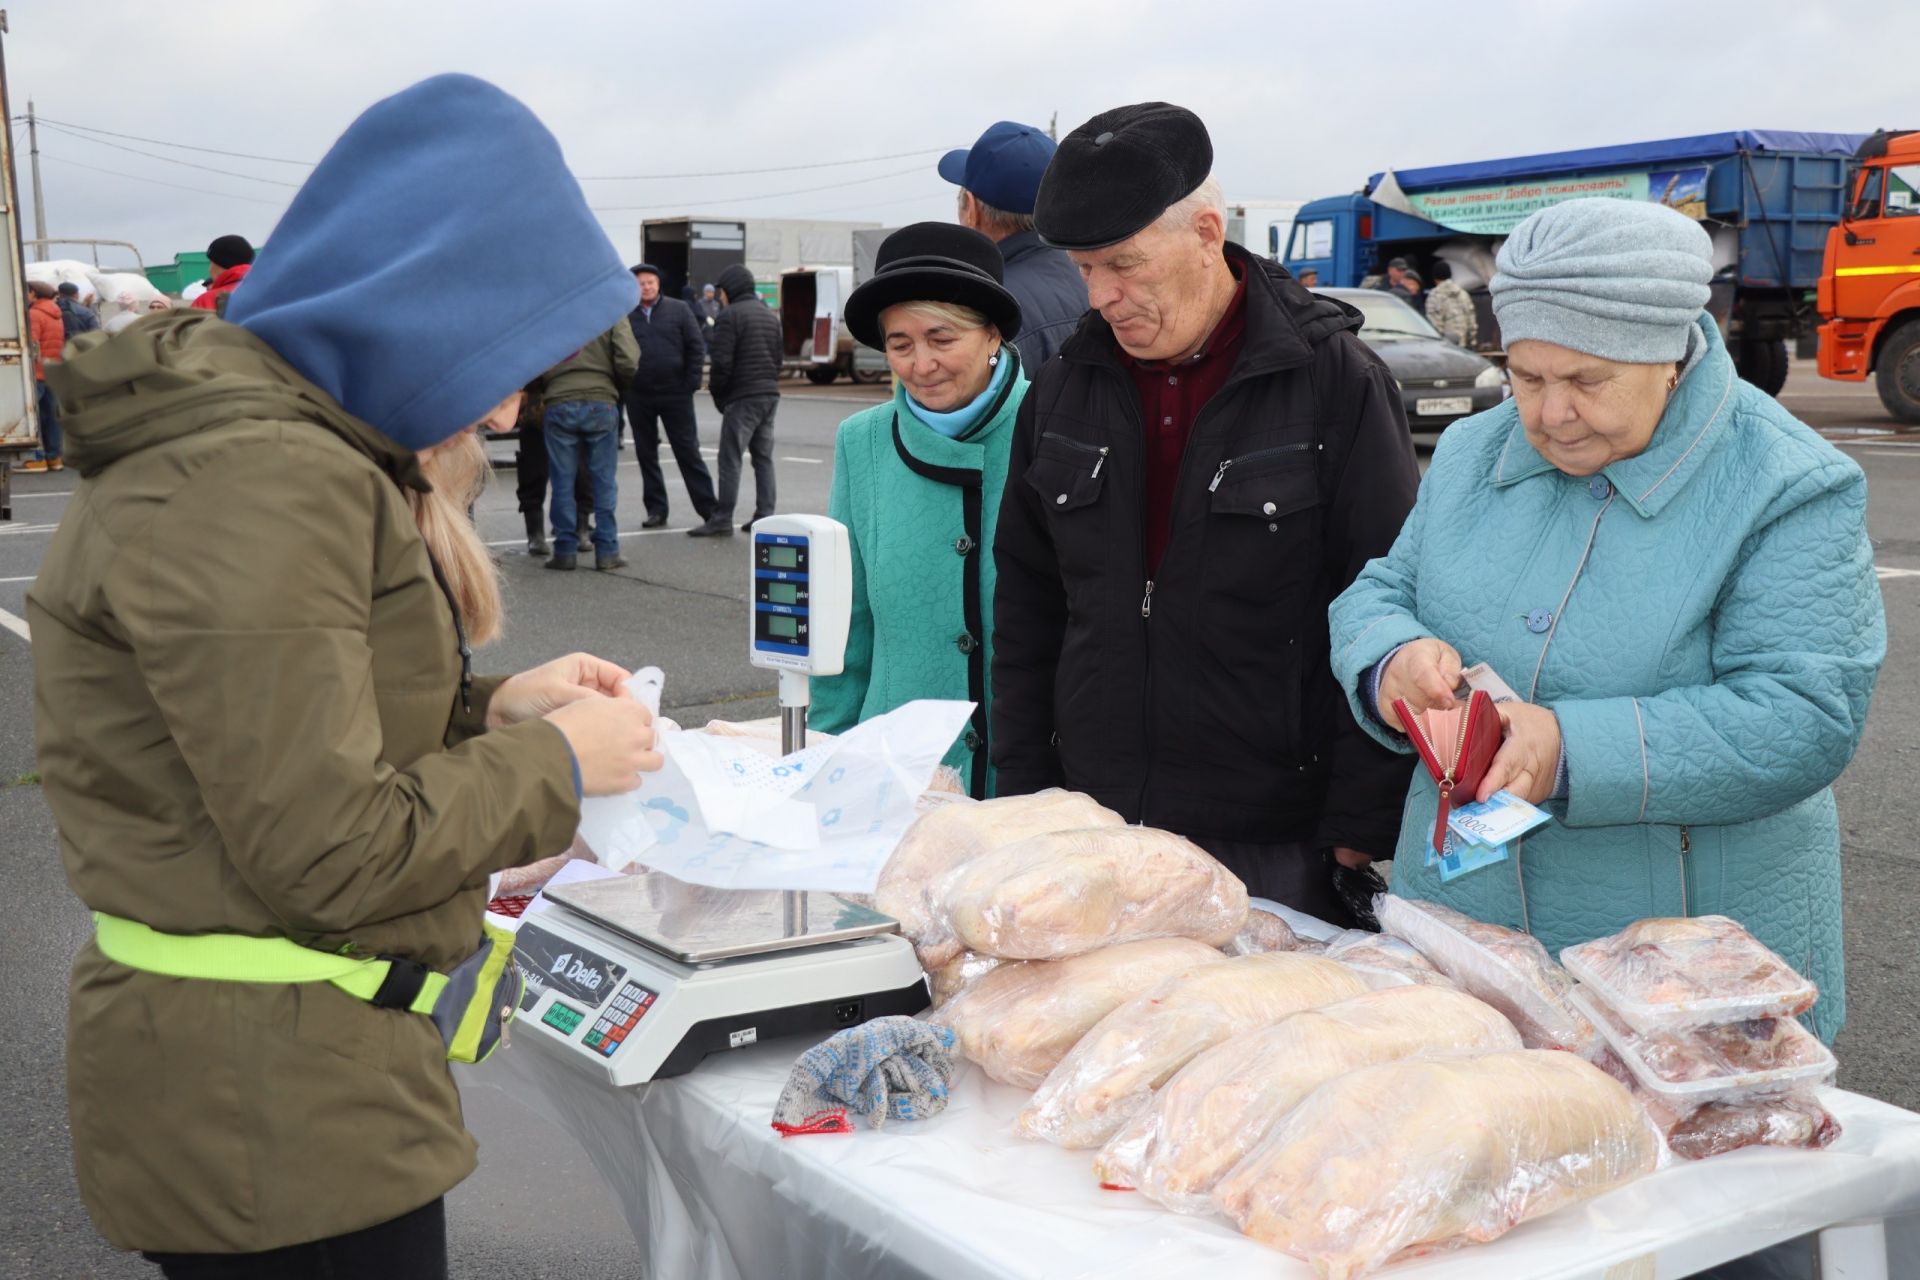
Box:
[513,516,927,1086]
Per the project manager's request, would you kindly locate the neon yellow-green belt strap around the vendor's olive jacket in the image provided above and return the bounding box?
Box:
[94,912,447,1013]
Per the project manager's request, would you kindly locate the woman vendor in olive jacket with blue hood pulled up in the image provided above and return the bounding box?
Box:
[27,75,660,1280]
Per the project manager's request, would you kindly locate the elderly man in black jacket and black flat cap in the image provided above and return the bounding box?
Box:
[991,104,1417,921]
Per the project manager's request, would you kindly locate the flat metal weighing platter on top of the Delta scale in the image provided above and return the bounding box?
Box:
[547,871,900,965]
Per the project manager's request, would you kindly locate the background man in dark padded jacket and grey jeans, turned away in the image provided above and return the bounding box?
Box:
[687,263,781,537]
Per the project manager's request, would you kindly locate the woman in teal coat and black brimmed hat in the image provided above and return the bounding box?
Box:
[812,223,1027,798]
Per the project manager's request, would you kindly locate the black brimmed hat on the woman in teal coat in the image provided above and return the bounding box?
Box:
[843,223,1020,351]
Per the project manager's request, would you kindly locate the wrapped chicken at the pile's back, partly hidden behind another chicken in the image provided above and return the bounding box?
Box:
[874,791,1125,973]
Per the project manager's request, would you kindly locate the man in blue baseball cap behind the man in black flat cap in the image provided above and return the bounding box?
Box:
[939,121,1087,374]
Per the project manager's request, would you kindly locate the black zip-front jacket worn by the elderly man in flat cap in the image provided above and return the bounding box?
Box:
[991,246,1428,858]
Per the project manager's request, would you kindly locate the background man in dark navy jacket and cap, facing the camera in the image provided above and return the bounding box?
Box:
[626,263,714,530]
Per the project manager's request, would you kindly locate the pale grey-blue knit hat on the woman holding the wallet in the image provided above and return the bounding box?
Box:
[1488,200,1713,365]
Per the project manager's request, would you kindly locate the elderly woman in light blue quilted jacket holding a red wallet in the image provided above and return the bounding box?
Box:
[1331,200,1885,1040]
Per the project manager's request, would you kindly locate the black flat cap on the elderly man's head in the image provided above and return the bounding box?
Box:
[1033,102,1213,249]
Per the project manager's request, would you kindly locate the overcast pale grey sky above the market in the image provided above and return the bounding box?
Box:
[6,0,1920,265]
